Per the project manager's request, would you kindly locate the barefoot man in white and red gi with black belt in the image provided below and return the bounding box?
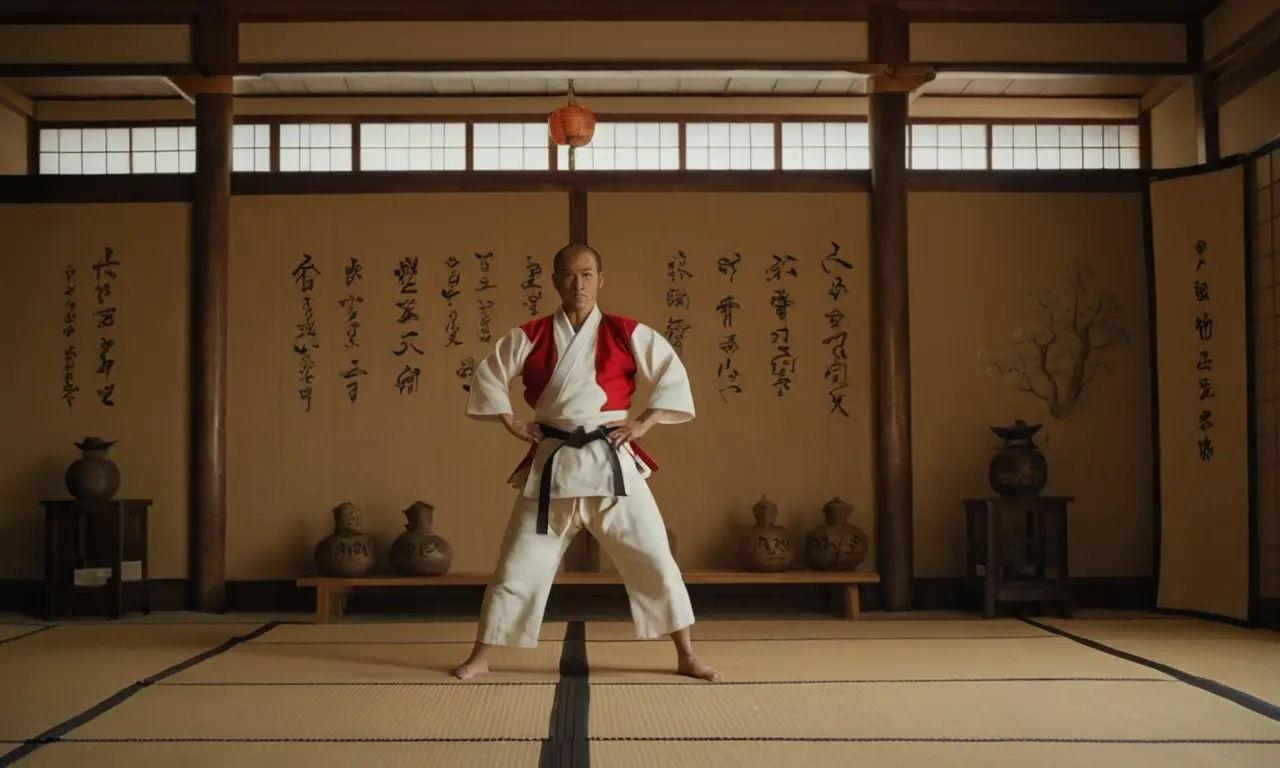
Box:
[453,244,719,681]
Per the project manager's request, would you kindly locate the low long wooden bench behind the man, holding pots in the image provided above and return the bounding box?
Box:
[297,571,879,623]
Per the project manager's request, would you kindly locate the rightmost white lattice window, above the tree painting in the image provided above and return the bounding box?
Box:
[991,124,1142,170]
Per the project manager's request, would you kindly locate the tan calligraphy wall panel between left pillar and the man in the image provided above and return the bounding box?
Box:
[227,193,568,580]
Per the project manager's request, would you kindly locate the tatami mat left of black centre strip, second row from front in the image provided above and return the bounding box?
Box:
[68,685,556,739]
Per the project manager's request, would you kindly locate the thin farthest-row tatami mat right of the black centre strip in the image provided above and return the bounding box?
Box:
[586,618,1052,643]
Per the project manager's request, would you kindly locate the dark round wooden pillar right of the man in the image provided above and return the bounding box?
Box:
[868,1,933,611]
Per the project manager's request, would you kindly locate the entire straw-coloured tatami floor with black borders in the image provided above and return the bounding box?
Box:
[0,614,1280,768]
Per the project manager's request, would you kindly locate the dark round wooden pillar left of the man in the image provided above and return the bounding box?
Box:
[188,0,237,612]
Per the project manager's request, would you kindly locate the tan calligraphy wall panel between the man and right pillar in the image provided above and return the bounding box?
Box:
[588,193,876,570]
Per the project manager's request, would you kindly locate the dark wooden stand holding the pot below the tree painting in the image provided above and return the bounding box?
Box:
[964,497,1075,618]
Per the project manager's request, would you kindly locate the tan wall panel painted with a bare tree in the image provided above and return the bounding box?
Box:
[909,192,1152,577]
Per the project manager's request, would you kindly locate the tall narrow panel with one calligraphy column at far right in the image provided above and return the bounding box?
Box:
[1151,165,1251,618]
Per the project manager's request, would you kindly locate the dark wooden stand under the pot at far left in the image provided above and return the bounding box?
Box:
[41,499,151,618]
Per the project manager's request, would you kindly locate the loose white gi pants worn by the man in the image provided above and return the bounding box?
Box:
[477,480,694,648]
